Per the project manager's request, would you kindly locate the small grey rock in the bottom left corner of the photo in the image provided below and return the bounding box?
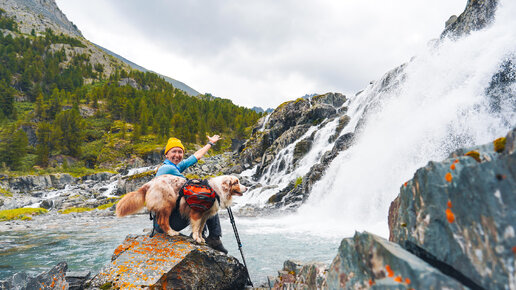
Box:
[0,262,68,290]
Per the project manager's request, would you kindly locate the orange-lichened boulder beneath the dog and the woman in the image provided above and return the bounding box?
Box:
[88,234,247,289]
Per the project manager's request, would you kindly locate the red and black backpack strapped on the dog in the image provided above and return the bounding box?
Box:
[179,179,220,212]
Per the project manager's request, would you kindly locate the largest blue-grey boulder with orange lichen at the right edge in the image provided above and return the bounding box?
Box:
[389,129,516,289]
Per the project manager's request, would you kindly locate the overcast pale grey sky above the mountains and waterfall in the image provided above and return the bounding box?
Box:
[56,0,466,108]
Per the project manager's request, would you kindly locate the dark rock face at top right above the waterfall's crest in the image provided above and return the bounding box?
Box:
[441,0,498,37]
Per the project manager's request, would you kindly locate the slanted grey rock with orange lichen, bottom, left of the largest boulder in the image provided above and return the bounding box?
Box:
[325,232,467,289]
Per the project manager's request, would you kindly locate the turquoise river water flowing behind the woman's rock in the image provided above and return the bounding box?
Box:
[0,215,340,285]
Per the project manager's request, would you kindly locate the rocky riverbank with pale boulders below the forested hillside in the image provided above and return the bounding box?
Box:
[0,152,242,221]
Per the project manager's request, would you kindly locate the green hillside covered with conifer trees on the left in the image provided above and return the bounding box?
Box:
[0,11,260,174]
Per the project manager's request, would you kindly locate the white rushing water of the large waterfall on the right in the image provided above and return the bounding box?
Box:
[243,1,516,237]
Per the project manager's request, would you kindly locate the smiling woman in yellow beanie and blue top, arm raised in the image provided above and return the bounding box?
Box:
[154,135,228,254]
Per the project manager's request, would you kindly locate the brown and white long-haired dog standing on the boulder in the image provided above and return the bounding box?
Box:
[116,174,247,243]
